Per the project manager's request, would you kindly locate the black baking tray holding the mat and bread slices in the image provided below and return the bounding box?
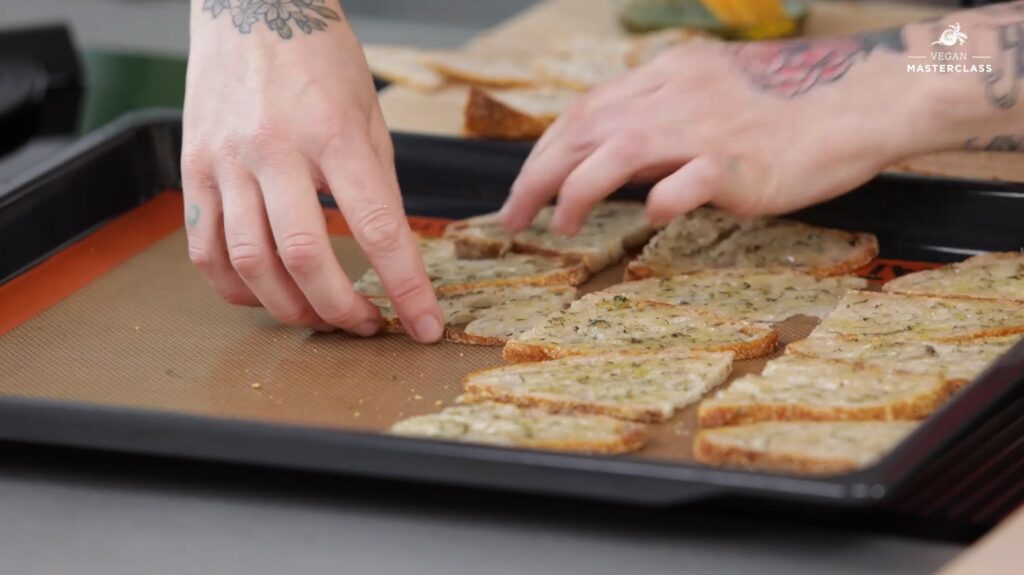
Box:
[0,110,1024,526]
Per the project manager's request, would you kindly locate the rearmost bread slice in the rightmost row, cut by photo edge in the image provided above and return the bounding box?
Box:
[882,252,1024,302]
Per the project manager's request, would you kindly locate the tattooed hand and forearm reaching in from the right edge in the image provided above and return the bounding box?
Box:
[503,0,1024,233]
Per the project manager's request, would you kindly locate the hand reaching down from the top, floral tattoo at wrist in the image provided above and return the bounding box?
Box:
[181,0,441,342]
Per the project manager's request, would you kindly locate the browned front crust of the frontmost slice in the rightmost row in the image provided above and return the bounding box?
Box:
[693,432,860,475]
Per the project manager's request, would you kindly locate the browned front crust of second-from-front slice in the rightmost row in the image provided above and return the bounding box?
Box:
[697,384,955,428]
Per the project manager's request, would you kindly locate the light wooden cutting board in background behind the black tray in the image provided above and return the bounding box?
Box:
[381,0,1024,182]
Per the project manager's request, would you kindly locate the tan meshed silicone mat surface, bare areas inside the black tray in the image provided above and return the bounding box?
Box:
[0,230,813,461]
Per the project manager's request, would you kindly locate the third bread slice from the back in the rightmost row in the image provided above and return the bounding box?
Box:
[785,334,1021,389]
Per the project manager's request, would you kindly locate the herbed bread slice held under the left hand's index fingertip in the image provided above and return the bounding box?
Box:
[370,285,577,337]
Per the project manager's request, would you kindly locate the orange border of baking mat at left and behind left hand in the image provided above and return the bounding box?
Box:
[0,189,449,336]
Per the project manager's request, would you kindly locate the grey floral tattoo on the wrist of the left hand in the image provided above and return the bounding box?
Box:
[203,0,341,40]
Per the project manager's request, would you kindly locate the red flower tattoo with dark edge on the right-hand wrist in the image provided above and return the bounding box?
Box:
[735,28,906,98]
